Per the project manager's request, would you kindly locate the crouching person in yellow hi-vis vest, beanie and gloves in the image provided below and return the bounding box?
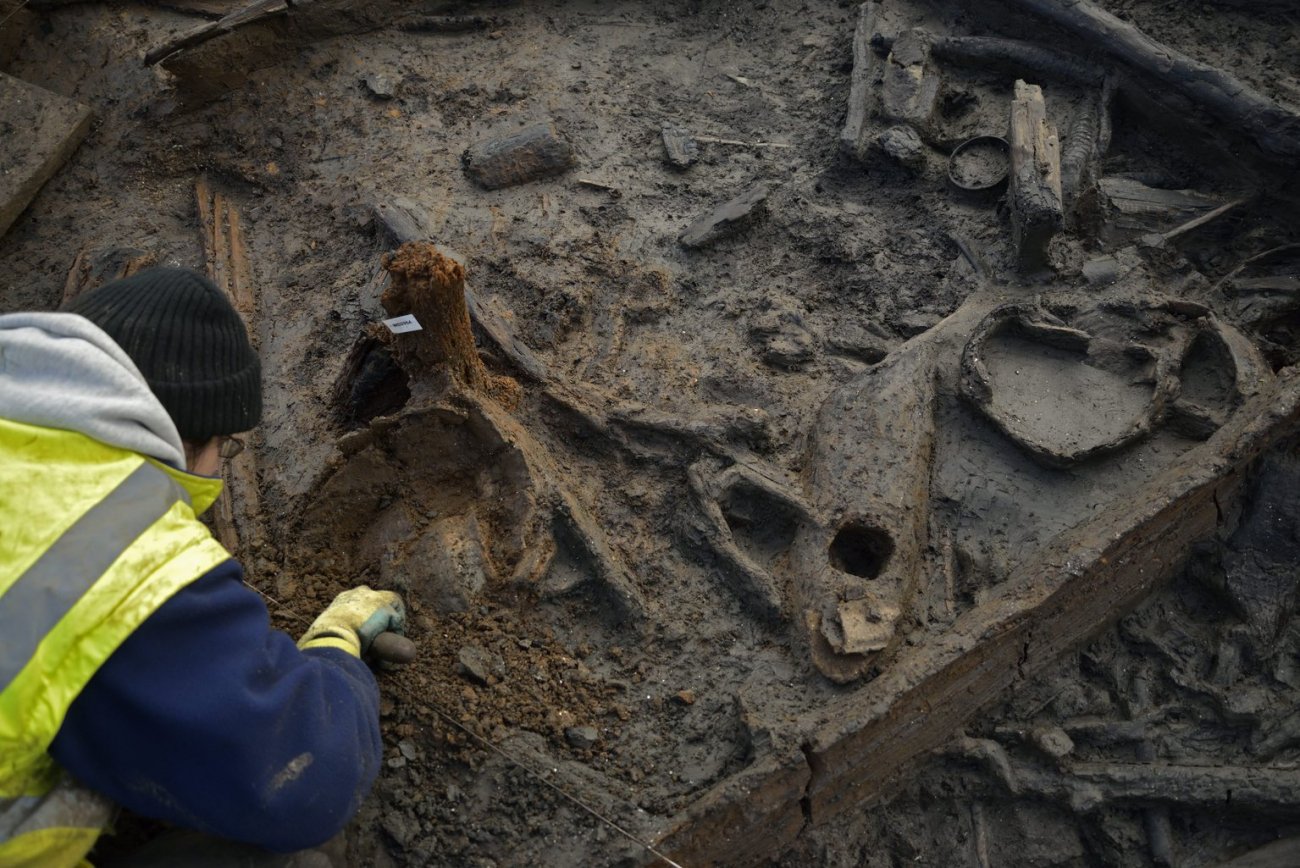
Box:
[0,269,404,868]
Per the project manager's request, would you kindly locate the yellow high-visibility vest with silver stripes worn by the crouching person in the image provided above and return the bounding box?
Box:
[0,418,230,868]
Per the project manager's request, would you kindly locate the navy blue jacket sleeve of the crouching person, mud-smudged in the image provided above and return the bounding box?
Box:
[49,560,384,852]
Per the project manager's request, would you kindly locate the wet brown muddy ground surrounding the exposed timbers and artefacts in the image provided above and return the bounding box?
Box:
[0,0,1300,868]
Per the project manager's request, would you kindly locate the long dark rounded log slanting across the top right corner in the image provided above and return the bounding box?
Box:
[1009,0,1300,160]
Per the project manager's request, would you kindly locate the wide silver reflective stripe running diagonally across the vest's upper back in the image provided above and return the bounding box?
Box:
[0,461,190,691]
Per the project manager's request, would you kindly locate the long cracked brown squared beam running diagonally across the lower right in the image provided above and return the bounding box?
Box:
[647,343,1300,864]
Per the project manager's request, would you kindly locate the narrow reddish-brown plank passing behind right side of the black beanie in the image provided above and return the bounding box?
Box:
[194,178,263,569]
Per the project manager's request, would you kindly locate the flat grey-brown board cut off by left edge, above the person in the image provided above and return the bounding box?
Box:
[0,73,92,235]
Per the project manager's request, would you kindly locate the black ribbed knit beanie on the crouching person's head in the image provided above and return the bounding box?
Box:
[64,268,261,443]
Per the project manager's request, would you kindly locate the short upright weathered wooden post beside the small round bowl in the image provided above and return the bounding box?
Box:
[1010,81,1065,270]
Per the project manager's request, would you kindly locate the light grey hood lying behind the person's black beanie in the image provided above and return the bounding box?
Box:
[0,313,185,469]
